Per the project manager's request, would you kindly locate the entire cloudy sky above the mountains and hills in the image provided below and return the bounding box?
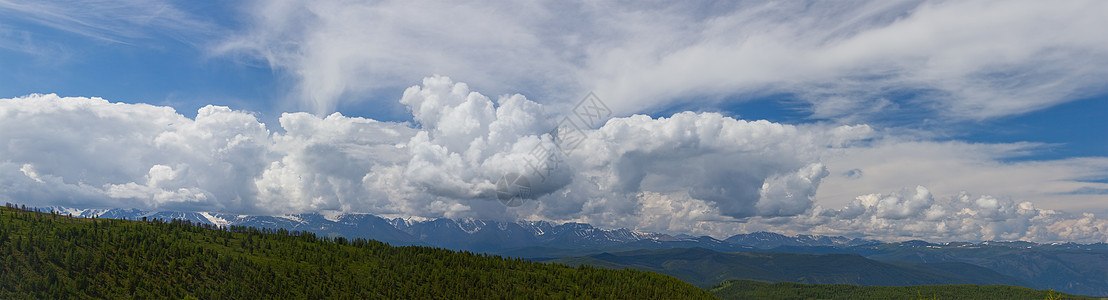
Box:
[0,0,1108,242]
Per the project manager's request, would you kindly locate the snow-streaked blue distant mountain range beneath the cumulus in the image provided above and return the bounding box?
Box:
[39,206,880,252]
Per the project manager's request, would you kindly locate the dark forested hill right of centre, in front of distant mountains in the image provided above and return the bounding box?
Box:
[551,248,1032,288]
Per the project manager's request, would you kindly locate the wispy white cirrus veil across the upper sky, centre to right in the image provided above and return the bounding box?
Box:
[214,1,1108,122]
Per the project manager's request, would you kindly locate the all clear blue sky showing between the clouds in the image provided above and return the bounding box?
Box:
[0,1,1108,159]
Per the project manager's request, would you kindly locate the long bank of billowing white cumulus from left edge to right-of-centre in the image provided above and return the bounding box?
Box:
[0,76,871,222]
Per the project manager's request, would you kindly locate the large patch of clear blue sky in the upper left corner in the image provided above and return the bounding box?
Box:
[0,0,274,119]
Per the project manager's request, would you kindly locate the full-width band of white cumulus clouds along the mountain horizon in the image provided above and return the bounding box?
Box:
[0,76,1108,242]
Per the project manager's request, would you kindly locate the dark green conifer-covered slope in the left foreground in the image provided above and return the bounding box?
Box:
[0,204,714,299]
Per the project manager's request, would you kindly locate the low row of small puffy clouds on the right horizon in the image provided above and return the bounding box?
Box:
[750,186,1108,242]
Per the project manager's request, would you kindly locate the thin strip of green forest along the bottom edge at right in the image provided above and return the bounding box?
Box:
[711,280,1097,300]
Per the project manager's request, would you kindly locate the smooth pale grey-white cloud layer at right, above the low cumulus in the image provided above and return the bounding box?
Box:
[818,140,1108,213]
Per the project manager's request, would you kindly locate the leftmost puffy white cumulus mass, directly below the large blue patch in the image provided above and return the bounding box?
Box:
[0,94,269,210]
